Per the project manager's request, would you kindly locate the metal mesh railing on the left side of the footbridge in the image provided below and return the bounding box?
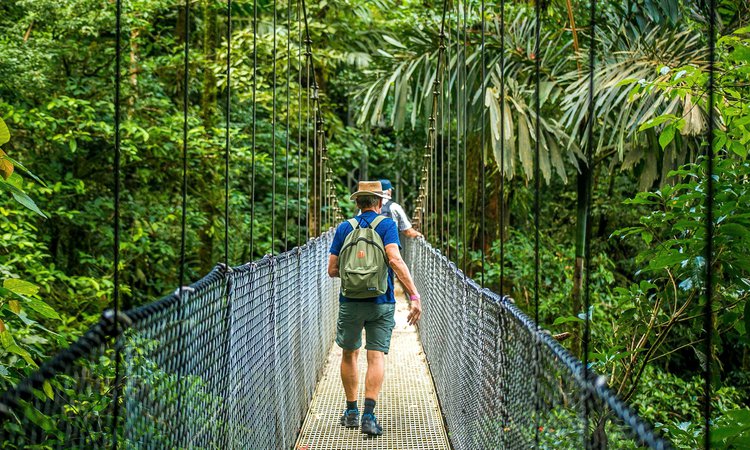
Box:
[0,232,338,449]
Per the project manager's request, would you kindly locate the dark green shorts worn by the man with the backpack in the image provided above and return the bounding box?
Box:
[336,302,396,354]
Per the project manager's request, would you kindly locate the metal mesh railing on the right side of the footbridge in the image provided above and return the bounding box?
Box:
[405,239,670,450]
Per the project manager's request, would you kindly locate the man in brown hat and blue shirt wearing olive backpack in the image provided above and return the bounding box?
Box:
[328,181,422,436]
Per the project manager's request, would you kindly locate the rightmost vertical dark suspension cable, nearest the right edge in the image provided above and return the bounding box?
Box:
[703,0,716,450]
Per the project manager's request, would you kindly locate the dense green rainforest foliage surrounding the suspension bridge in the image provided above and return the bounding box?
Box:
[0,0,750,448]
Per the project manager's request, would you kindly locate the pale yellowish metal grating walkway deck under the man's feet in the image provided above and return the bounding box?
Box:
[295,295,450,450]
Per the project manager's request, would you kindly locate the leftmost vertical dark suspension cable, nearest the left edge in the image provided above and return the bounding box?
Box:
[112,0,127,450]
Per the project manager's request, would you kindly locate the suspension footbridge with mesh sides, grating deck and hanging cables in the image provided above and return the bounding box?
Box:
[0,1,724,450]
